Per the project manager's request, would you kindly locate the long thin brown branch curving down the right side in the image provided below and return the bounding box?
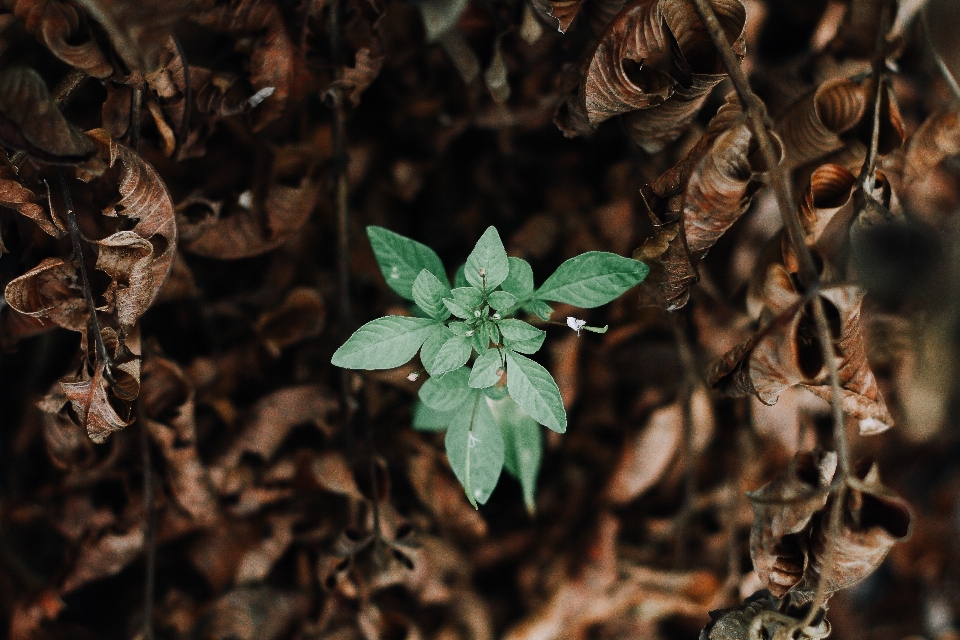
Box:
[691,0,856,629]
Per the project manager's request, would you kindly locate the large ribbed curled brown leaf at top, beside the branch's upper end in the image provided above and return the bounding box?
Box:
[558,0,746,153]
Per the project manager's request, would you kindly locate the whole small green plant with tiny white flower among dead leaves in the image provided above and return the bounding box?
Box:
[332,226,649,511]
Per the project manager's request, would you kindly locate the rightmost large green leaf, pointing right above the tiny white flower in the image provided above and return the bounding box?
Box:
[536,251,650,309]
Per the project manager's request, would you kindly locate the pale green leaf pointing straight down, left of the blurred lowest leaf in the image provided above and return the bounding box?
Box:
[445,392,504,508]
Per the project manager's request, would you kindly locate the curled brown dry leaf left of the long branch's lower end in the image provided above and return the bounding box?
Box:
[747,452,837,598]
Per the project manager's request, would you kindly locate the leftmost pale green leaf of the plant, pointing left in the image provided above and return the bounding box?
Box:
[330,316,443,369]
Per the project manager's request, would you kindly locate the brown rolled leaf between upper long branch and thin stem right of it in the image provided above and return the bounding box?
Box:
[776,78,867,168]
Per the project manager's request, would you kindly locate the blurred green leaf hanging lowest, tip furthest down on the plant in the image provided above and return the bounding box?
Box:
[489,396,543,515]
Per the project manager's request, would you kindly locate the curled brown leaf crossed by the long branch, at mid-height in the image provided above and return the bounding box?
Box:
[708,264,893,434]
